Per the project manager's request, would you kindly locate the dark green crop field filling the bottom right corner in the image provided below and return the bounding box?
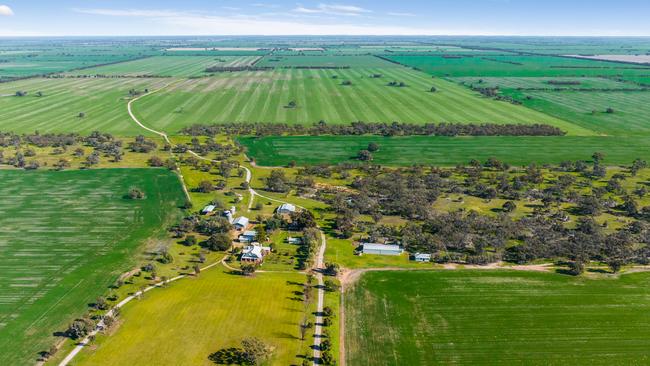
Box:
[345,271,650,365]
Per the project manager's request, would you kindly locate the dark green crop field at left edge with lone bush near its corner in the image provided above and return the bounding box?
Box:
[0,169,184,365]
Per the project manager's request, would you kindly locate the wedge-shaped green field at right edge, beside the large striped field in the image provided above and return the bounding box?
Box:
[504,90,650,136]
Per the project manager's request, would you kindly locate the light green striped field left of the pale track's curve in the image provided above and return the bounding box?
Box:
[0,78,170,136]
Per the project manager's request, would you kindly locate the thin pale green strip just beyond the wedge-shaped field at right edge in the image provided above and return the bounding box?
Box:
[451,77,643,90]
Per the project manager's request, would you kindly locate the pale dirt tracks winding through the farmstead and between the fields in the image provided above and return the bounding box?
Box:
[59,88,327,366]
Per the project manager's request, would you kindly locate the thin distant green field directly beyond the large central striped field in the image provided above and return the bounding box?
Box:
[258,54,399,68]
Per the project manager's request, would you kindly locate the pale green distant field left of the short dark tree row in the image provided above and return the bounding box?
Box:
[72,56,259,77]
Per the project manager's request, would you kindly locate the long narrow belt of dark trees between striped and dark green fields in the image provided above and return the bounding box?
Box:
[183,121,565,137]
